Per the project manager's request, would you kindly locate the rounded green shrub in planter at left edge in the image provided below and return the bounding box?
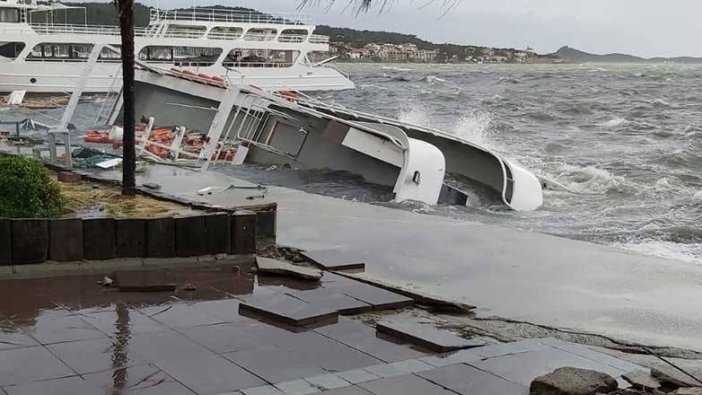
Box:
[0,156,64,218]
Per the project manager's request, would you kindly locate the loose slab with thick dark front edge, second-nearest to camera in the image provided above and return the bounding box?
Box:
[239,294,339,327]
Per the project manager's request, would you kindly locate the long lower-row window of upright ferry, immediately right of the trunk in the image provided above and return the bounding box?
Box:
[139,46,222,67]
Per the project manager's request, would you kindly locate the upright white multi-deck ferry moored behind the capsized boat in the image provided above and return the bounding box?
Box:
[0,0,354,93]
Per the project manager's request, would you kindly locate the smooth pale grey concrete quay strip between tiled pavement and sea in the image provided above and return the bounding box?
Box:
[66,166,702,351]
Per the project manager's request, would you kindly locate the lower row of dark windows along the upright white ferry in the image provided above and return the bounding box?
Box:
[0,42,300,67]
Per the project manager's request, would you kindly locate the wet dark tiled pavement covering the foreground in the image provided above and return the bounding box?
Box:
[0,262,640,395]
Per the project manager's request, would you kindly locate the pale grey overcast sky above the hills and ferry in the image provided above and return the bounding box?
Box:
[128,0,702,57]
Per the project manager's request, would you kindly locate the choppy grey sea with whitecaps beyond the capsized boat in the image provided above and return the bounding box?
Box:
[319,64,702,264]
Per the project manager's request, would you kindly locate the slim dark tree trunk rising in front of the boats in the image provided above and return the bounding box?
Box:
[114,0,136,196]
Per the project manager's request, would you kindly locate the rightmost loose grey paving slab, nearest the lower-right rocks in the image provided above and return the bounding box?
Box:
[376,321,485,353]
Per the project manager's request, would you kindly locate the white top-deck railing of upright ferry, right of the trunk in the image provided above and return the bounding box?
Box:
[151,8,314,25]
